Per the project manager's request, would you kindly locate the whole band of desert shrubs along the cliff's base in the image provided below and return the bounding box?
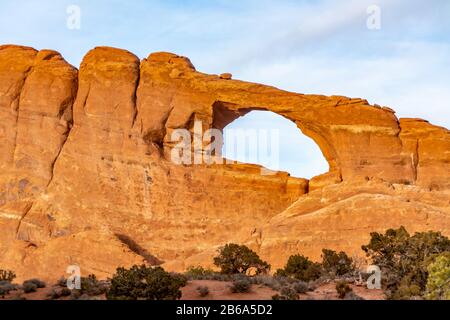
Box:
[0,227,450,300]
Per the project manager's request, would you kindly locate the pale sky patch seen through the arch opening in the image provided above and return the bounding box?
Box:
[222,111,329,179]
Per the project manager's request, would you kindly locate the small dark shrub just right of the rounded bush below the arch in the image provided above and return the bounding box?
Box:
[275,254,322,282]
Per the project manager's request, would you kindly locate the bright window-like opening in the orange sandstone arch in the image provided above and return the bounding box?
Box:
[220,109,329,179]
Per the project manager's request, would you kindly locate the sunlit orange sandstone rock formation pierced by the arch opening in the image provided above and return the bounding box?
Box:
[0,46,450,279]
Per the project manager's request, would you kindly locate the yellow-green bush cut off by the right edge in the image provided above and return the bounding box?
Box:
[426,252,450,300]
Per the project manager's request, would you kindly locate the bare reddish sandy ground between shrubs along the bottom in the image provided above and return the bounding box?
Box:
[0,280,385,300]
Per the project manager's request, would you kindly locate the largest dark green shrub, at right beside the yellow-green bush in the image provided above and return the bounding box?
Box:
[362,227,450,299]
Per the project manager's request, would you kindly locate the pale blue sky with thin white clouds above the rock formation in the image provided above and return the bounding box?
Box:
[0,0,450,178]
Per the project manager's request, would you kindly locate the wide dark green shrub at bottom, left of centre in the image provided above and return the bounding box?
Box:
[106,265,183,300]
